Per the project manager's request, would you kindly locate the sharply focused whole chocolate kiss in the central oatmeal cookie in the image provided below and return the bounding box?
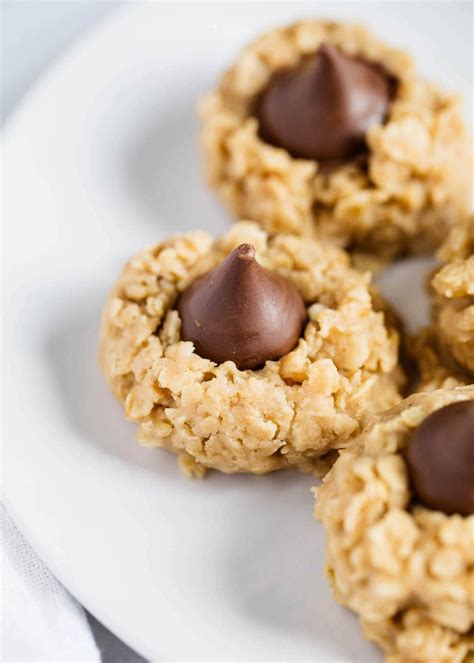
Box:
[178,244,306,370]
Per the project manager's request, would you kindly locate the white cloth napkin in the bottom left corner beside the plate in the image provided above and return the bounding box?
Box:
[0,504,100,663]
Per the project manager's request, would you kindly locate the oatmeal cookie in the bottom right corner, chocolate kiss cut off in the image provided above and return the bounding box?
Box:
[315,386,474,663]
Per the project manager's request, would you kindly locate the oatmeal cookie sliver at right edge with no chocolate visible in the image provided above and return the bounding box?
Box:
[414,217,474,390]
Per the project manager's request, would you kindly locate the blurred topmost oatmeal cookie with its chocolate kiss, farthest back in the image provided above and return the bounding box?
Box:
[199,21,472,259]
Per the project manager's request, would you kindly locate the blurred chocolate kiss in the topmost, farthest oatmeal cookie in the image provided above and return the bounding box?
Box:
[256,44,393,161]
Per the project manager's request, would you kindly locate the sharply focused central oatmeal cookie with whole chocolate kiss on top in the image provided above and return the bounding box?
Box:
[99,222,400,474]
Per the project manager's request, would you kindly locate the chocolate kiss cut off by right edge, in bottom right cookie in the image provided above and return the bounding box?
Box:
[407,401,474,516]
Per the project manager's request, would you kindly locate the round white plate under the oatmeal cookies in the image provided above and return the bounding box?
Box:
[3,3,470,662]
